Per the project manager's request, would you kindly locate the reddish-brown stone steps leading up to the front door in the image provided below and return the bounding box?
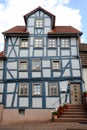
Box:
[54,105,87,122]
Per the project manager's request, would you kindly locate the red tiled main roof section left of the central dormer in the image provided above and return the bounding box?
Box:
[3,26,29,35]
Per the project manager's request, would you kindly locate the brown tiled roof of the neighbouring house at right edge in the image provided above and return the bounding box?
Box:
[79,44,87,68]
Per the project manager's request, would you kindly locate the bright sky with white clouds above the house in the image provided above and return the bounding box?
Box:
[0,0,87,51]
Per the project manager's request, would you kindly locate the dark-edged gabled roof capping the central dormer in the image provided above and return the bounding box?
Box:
[24,6,55,28]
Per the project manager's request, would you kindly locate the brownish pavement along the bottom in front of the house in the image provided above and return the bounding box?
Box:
[0,121,87,130]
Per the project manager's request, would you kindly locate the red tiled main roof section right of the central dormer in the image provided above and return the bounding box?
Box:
[48,26,82,35]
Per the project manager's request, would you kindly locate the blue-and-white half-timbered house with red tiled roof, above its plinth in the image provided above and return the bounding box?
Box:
[0,7,83,121]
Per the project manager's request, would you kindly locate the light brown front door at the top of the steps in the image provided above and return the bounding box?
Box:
[70,83,82,104]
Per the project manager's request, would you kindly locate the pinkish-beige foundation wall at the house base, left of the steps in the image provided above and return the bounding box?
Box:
[3,109,52,123]
